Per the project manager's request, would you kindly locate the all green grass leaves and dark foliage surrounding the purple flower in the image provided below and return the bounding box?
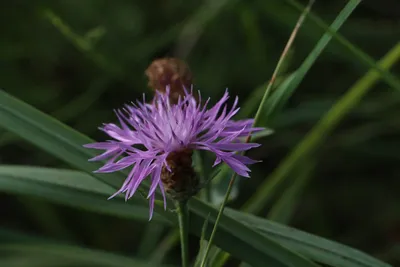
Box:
[0,0,400,267]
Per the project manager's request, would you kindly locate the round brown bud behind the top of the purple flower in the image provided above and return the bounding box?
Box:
[145,58,192,104]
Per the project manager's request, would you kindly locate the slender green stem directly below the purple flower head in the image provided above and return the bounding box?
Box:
[176,201,189,267]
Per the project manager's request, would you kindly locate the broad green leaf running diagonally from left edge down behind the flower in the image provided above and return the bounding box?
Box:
[0,91,315,267]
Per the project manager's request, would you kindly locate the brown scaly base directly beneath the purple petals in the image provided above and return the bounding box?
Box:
[161,149,200,201]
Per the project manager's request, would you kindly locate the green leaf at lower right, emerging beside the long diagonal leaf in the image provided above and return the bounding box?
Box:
[226,209,390,267]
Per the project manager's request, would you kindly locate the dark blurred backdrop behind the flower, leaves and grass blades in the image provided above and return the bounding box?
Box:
[0,0,400,266]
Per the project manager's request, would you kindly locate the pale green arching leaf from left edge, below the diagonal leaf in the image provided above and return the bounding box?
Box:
[0,165,170,224]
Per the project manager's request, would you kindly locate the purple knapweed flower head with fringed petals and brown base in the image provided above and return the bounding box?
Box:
[85,89,263,218]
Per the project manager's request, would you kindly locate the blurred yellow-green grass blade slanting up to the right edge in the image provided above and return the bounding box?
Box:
[243,43,400,213]
